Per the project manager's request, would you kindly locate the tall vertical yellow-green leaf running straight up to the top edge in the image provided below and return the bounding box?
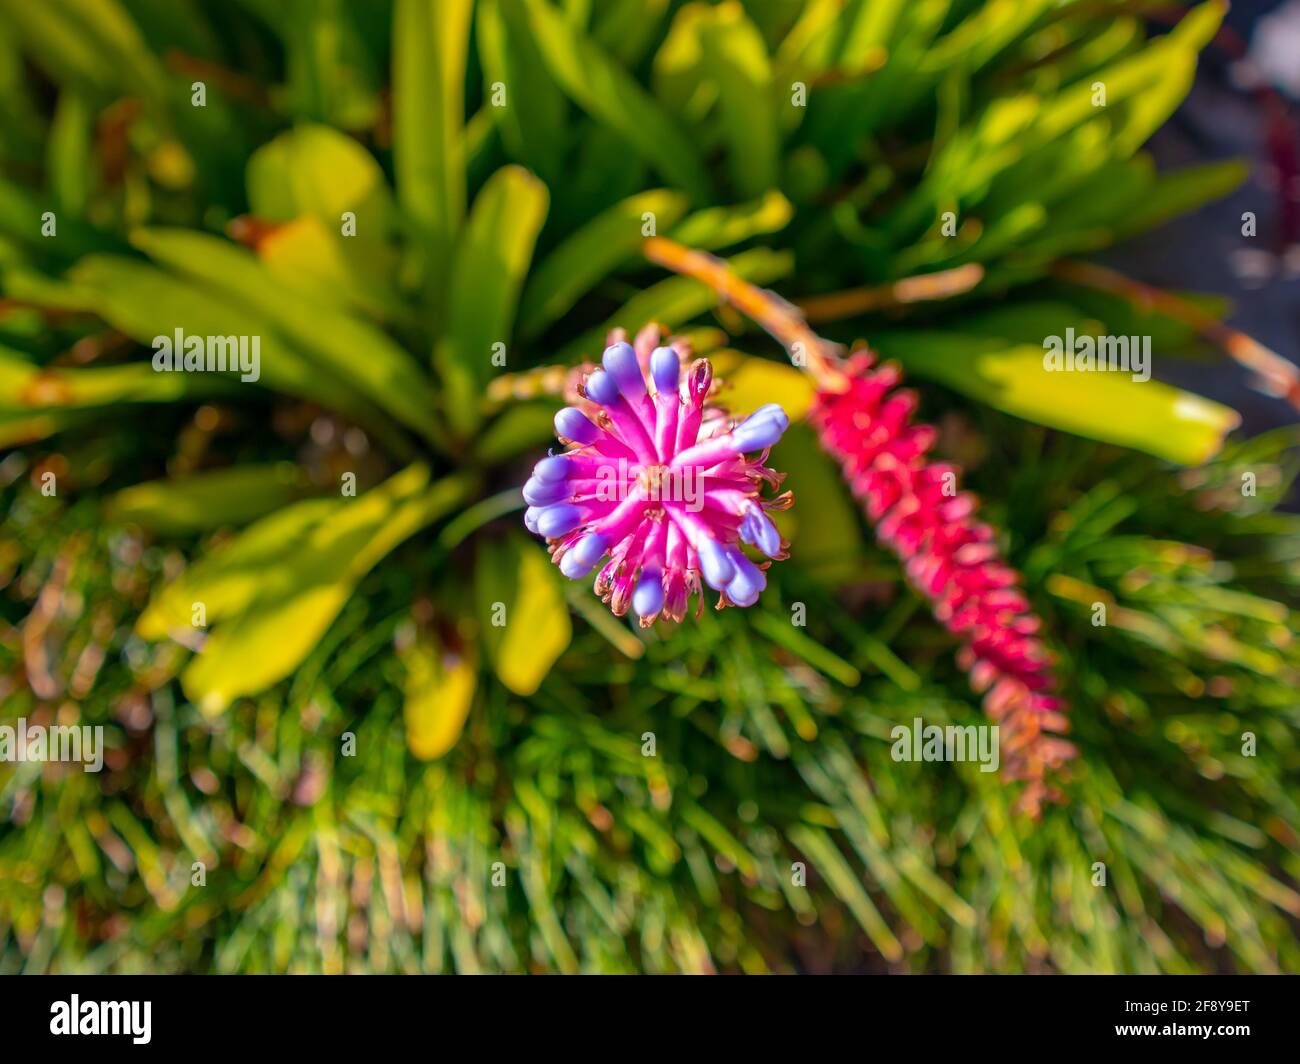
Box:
[393,0,472,287]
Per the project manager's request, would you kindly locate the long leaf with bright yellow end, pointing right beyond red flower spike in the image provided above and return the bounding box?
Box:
[874,326,1240,466]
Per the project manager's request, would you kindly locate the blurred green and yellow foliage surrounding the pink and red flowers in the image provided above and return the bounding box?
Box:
[0,0,1300,972]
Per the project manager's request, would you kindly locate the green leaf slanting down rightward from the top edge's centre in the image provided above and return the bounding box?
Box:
[527,0,710,202]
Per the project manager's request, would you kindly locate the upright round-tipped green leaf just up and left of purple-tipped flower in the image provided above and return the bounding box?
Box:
[434,166,547,433]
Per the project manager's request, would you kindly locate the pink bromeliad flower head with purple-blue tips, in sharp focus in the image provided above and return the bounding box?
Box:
[524,342,790,627]
